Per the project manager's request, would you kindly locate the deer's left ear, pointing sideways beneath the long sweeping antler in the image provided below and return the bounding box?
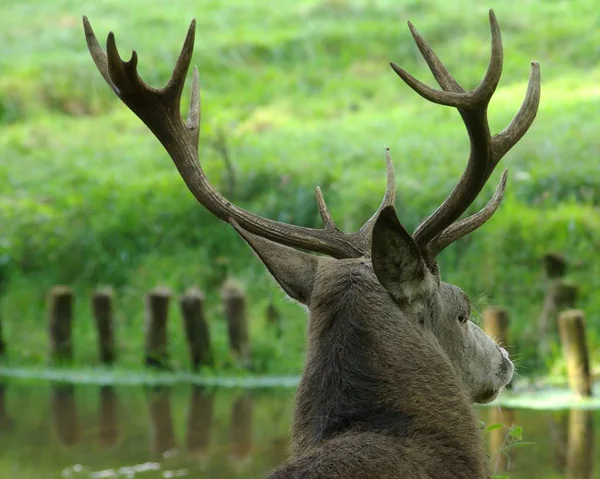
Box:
[230,220,318,305]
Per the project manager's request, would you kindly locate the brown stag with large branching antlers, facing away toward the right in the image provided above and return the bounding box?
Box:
[83,10,540,479]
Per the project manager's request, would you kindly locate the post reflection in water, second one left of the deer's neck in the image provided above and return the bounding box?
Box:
[186,386,213,460]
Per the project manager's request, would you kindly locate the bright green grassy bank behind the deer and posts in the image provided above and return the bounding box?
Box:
[0,0,600,374]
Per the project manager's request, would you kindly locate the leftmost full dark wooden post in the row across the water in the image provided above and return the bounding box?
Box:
[48,286,74,362]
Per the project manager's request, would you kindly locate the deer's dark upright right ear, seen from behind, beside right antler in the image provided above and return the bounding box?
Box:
[371,206,428,301]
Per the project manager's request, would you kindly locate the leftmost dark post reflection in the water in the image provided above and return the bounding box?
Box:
[50,384,80,446]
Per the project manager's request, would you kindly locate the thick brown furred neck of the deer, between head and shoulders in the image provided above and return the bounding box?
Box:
[292,272,485,477]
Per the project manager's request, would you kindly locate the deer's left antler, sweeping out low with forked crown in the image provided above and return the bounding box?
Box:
[83,16,396,258]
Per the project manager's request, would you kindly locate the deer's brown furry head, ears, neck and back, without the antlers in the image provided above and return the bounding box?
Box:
[236,207,512,479]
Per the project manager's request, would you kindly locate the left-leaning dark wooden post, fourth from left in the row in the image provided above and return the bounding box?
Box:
[179,287,213,370]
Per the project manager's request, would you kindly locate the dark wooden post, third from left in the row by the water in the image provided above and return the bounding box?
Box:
[145,288,171,369]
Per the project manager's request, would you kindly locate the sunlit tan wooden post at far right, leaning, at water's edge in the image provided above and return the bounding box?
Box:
[558,309,592,397]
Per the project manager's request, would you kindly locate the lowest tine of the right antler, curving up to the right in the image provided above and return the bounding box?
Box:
[428,168,508,258]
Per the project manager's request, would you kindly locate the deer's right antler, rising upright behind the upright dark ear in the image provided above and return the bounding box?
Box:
[391,10,540,264]
